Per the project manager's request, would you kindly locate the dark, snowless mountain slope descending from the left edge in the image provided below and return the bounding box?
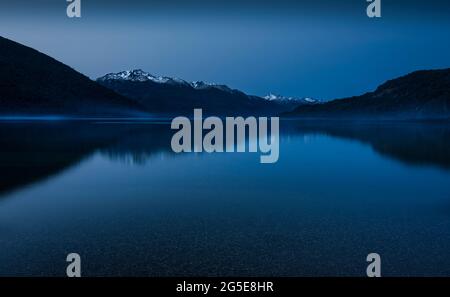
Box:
[0,37,143,116]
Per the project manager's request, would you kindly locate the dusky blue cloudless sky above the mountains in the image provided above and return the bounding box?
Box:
[0,0,450,99]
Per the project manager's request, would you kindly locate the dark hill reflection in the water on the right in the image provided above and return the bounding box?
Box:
[285,121,450,169]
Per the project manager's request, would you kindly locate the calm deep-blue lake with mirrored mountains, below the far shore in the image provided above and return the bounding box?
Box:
[0,121,450,276]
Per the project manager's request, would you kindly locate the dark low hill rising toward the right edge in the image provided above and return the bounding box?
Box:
[283,69,450,120]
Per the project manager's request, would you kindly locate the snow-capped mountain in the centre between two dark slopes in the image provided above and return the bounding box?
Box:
[97,69,299,116]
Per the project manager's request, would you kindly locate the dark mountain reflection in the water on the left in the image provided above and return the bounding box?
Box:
[0,122,170,193]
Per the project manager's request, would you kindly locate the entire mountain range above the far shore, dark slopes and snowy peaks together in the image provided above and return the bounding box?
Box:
[0,37,450,120]
